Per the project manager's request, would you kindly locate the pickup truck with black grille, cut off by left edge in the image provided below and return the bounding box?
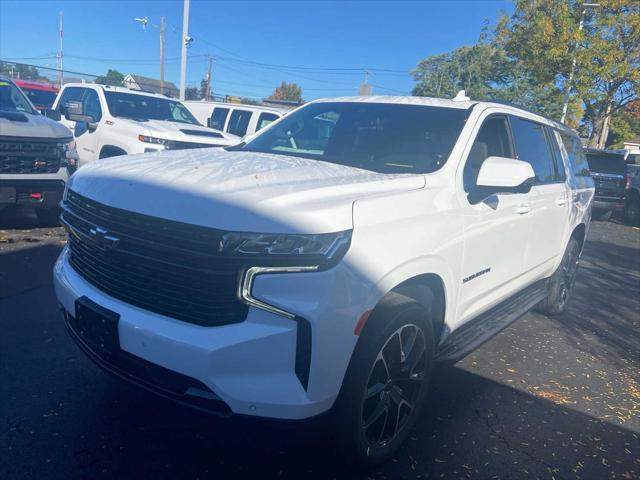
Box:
[0,76,77,225]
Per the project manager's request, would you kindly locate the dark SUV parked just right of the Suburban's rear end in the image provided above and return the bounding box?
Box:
[586,149,627,220]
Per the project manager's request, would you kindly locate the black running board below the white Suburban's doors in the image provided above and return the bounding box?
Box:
[436,280,547,363]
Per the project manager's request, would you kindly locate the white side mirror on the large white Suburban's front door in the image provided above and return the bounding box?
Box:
[476,157,536,188]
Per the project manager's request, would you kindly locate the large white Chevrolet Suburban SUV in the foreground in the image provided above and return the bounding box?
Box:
[54,96,594,463]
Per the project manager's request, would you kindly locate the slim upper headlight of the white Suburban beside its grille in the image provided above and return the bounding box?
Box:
[218,230,351,268]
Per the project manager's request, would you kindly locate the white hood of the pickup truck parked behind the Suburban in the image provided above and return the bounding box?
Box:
[118,118,241,145]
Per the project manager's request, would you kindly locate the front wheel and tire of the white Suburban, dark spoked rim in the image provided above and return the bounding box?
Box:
[333,293,435,466]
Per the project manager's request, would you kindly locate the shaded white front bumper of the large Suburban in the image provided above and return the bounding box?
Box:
[54,249,372,419]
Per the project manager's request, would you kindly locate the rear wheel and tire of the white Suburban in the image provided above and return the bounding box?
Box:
[536,237,580,316]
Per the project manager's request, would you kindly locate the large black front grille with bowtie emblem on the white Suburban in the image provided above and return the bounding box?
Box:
[62,191,248,326]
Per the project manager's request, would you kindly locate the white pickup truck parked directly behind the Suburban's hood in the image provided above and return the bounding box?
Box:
[53,83,240,167]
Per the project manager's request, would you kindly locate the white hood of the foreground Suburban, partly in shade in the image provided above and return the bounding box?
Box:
[68,149,425,233]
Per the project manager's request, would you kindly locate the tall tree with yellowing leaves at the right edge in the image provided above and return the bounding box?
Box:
[493,0,640,148]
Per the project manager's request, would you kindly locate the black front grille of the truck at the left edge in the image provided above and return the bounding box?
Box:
[0,140,63,175]
